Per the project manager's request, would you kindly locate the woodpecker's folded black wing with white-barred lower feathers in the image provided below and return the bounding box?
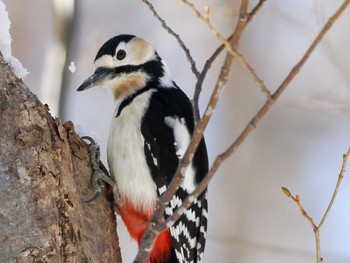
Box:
[141,87,208,262]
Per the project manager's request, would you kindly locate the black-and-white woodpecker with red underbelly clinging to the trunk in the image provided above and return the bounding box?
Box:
[78,35,208,263]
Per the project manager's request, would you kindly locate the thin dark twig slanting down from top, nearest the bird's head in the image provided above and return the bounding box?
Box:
[142,0,199,79]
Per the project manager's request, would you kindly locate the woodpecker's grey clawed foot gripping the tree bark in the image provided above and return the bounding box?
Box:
[81,136,115,203]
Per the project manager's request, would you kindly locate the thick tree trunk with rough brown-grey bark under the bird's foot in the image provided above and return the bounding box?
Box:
[0,53,121,262]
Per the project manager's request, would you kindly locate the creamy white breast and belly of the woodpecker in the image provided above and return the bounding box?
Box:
[107,91,157,210]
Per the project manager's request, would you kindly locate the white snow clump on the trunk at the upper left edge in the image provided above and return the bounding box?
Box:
[0,0,29,79]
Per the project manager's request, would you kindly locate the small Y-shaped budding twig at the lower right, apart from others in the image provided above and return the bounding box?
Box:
[282,148,350,263]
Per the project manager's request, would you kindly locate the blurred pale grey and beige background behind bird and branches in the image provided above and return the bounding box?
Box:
[4,0,350,263]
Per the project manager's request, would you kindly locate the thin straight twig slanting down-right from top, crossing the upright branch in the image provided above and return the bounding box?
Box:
[181,0,271,100]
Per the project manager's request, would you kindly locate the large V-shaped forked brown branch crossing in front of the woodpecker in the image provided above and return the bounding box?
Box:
[134,0,350,263]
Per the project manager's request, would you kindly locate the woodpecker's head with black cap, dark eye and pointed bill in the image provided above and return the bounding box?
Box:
[78,35,171,100]
